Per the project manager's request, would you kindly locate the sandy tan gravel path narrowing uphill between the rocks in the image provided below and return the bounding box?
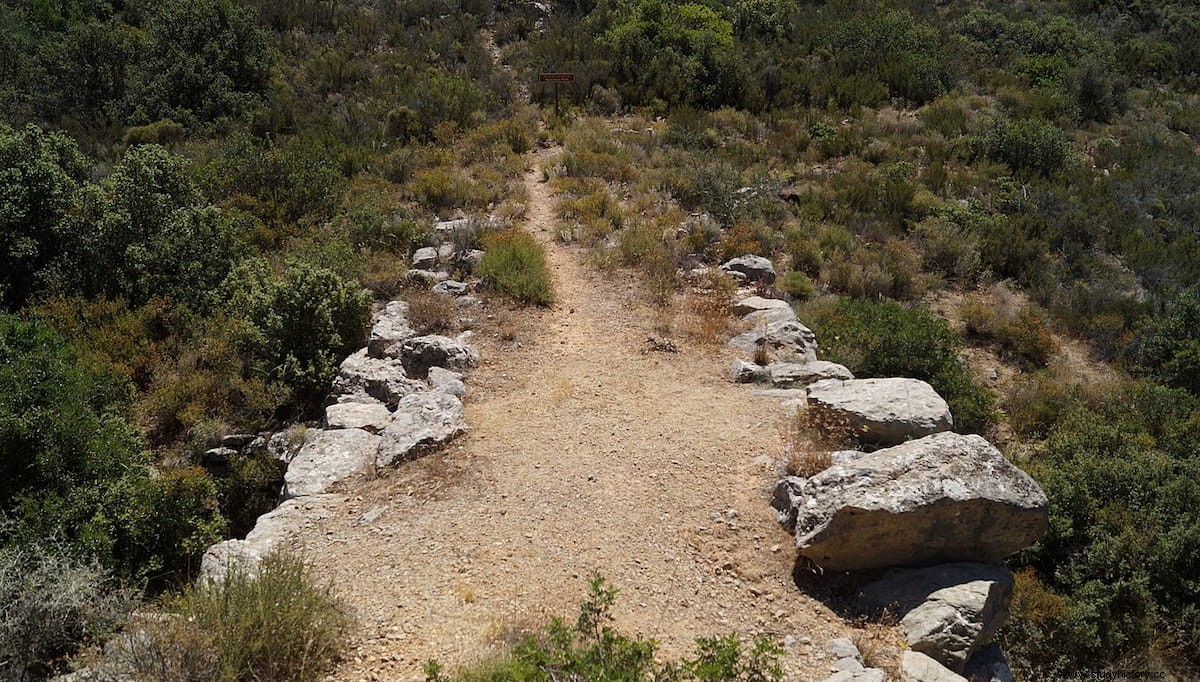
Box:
[304,152,845,680]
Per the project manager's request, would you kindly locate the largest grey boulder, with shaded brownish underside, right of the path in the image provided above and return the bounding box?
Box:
[776,432,1048,570]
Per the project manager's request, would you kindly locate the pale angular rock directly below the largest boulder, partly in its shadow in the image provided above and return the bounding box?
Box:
[860,563,1013,672]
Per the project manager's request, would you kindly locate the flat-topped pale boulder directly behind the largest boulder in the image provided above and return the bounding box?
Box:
[808,378,954,447]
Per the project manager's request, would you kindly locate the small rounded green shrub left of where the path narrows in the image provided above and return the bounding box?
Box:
[479,229,554,305]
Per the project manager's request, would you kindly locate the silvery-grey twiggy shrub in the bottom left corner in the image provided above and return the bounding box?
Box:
[0,539,134,682]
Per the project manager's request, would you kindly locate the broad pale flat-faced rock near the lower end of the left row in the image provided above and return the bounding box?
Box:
[283,429,376,498]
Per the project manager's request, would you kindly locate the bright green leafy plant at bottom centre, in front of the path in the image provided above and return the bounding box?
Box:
[425,575,784,682]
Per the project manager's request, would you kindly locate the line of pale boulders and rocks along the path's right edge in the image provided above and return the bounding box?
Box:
[722,257,1049,682]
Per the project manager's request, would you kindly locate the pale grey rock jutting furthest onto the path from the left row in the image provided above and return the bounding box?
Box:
[376,390,467,466]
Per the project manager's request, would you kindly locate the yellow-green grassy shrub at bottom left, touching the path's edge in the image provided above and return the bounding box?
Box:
[117,554,349,682]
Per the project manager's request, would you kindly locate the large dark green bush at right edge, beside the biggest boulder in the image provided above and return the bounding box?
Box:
[1004,383,1200,678]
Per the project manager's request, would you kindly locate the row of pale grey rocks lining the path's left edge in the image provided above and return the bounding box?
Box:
[200,301,479,580]
